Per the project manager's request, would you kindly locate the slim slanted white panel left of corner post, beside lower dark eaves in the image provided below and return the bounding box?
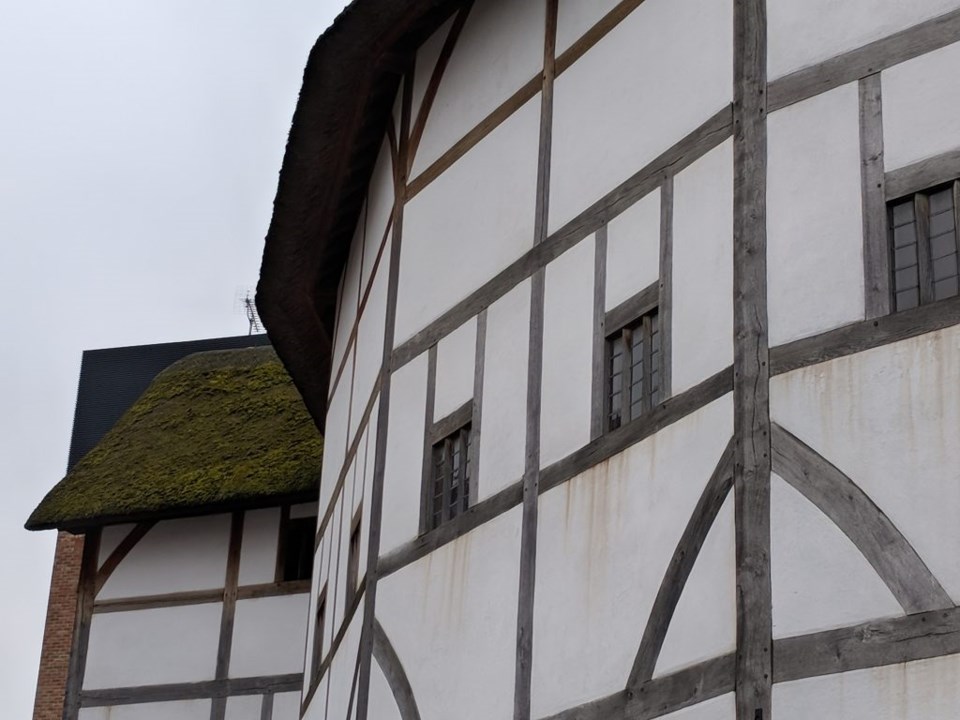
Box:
[349,239,390,440]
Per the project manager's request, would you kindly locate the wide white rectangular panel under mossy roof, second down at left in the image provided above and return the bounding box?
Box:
[83,603,222,690]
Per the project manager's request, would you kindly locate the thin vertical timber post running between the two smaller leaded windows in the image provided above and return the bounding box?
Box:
[513,0,558,720]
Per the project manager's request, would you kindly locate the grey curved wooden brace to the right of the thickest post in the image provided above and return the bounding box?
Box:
[772,424,954,614]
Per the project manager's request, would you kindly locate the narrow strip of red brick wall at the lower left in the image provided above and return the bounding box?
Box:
[33,532,83,720]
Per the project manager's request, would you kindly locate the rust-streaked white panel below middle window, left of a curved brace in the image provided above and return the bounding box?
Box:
[533,396,733,717]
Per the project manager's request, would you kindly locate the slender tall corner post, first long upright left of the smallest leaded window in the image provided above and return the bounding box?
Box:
[356,62,413,720]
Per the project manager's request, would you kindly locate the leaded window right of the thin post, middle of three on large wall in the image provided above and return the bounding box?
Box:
[605,307,661,430]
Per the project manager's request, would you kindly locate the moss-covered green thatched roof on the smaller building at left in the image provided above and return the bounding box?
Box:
[26,347,323,530]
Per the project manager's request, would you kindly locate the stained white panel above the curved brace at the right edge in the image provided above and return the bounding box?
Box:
[770,327,960,601]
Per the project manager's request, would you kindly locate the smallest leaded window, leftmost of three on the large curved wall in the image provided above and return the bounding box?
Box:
[426,423,470,530]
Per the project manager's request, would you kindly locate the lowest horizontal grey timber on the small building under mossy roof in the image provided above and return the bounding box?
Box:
[80,673,303,707]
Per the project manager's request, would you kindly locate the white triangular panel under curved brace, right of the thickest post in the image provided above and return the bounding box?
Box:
[770,475,903,638]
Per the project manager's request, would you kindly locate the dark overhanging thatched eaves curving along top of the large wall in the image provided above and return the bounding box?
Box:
[257,0,464,429]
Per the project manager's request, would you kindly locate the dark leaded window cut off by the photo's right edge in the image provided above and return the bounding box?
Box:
[889,180,960,310]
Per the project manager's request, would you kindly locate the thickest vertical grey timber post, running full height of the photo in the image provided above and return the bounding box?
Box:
[733,0,773,720]
